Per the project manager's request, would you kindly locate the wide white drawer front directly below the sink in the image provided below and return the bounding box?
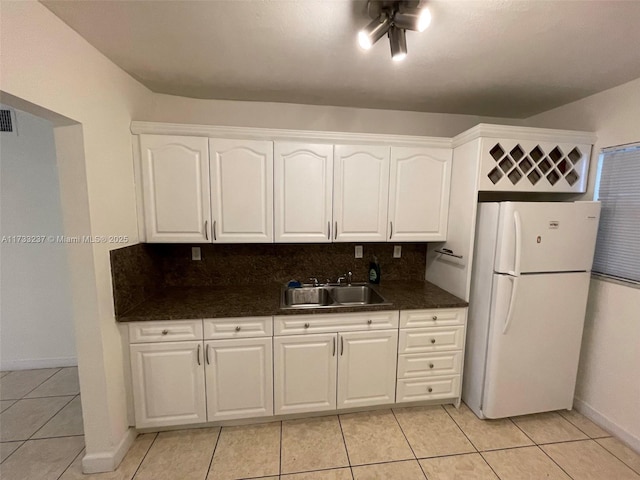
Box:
[274,310,399,335]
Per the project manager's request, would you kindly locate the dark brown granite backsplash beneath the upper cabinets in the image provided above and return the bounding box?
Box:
[111,243,427,315]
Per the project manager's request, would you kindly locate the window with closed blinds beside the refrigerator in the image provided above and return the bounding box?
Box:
[593,143,640,283]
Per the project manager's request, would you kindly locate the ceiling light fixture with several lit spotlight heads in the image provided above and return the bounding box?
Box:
[358,0,431,61]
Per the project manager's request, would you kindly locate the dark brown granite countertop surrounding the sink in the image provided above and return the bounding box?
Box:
[117,281,468,322]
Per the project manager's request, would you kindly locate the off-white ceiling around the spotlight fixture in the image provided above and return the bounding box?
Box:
[42,0,640,118]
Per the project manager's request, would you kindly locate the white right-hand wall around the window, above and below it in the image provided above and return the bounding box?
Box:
[527,79,640,451]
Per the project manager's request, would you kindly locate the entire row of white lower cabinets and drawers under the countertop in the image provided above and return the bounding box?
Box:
[129,308,466,428]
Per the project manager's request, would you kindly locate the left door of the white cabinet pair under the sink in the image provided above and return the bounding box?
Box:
[273,334,337,415]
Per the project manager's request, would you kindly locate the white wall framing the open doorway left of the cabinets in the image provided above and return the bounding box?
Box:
[0,1,151,471]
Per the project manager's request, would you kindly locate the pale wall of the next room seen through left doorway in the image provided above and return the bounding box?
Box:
[0,110,77,370]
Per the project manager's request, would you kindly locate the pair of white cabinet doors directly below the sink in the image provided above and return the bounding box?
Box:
[273,330,398,415]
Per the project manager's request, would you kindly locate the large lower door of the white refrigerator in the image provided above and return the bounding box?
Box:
[482,272,590,418]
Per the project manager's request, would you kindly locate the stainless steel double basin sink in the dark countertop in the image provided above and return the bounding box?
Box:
[281,284,390,309]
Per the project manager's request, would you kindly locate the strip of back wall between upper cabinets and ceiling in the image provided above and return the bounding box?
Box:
[144,95,524,137]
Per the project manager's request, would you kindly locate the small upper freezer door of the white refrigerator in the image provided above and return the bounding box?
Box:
[494,202,600,275]
